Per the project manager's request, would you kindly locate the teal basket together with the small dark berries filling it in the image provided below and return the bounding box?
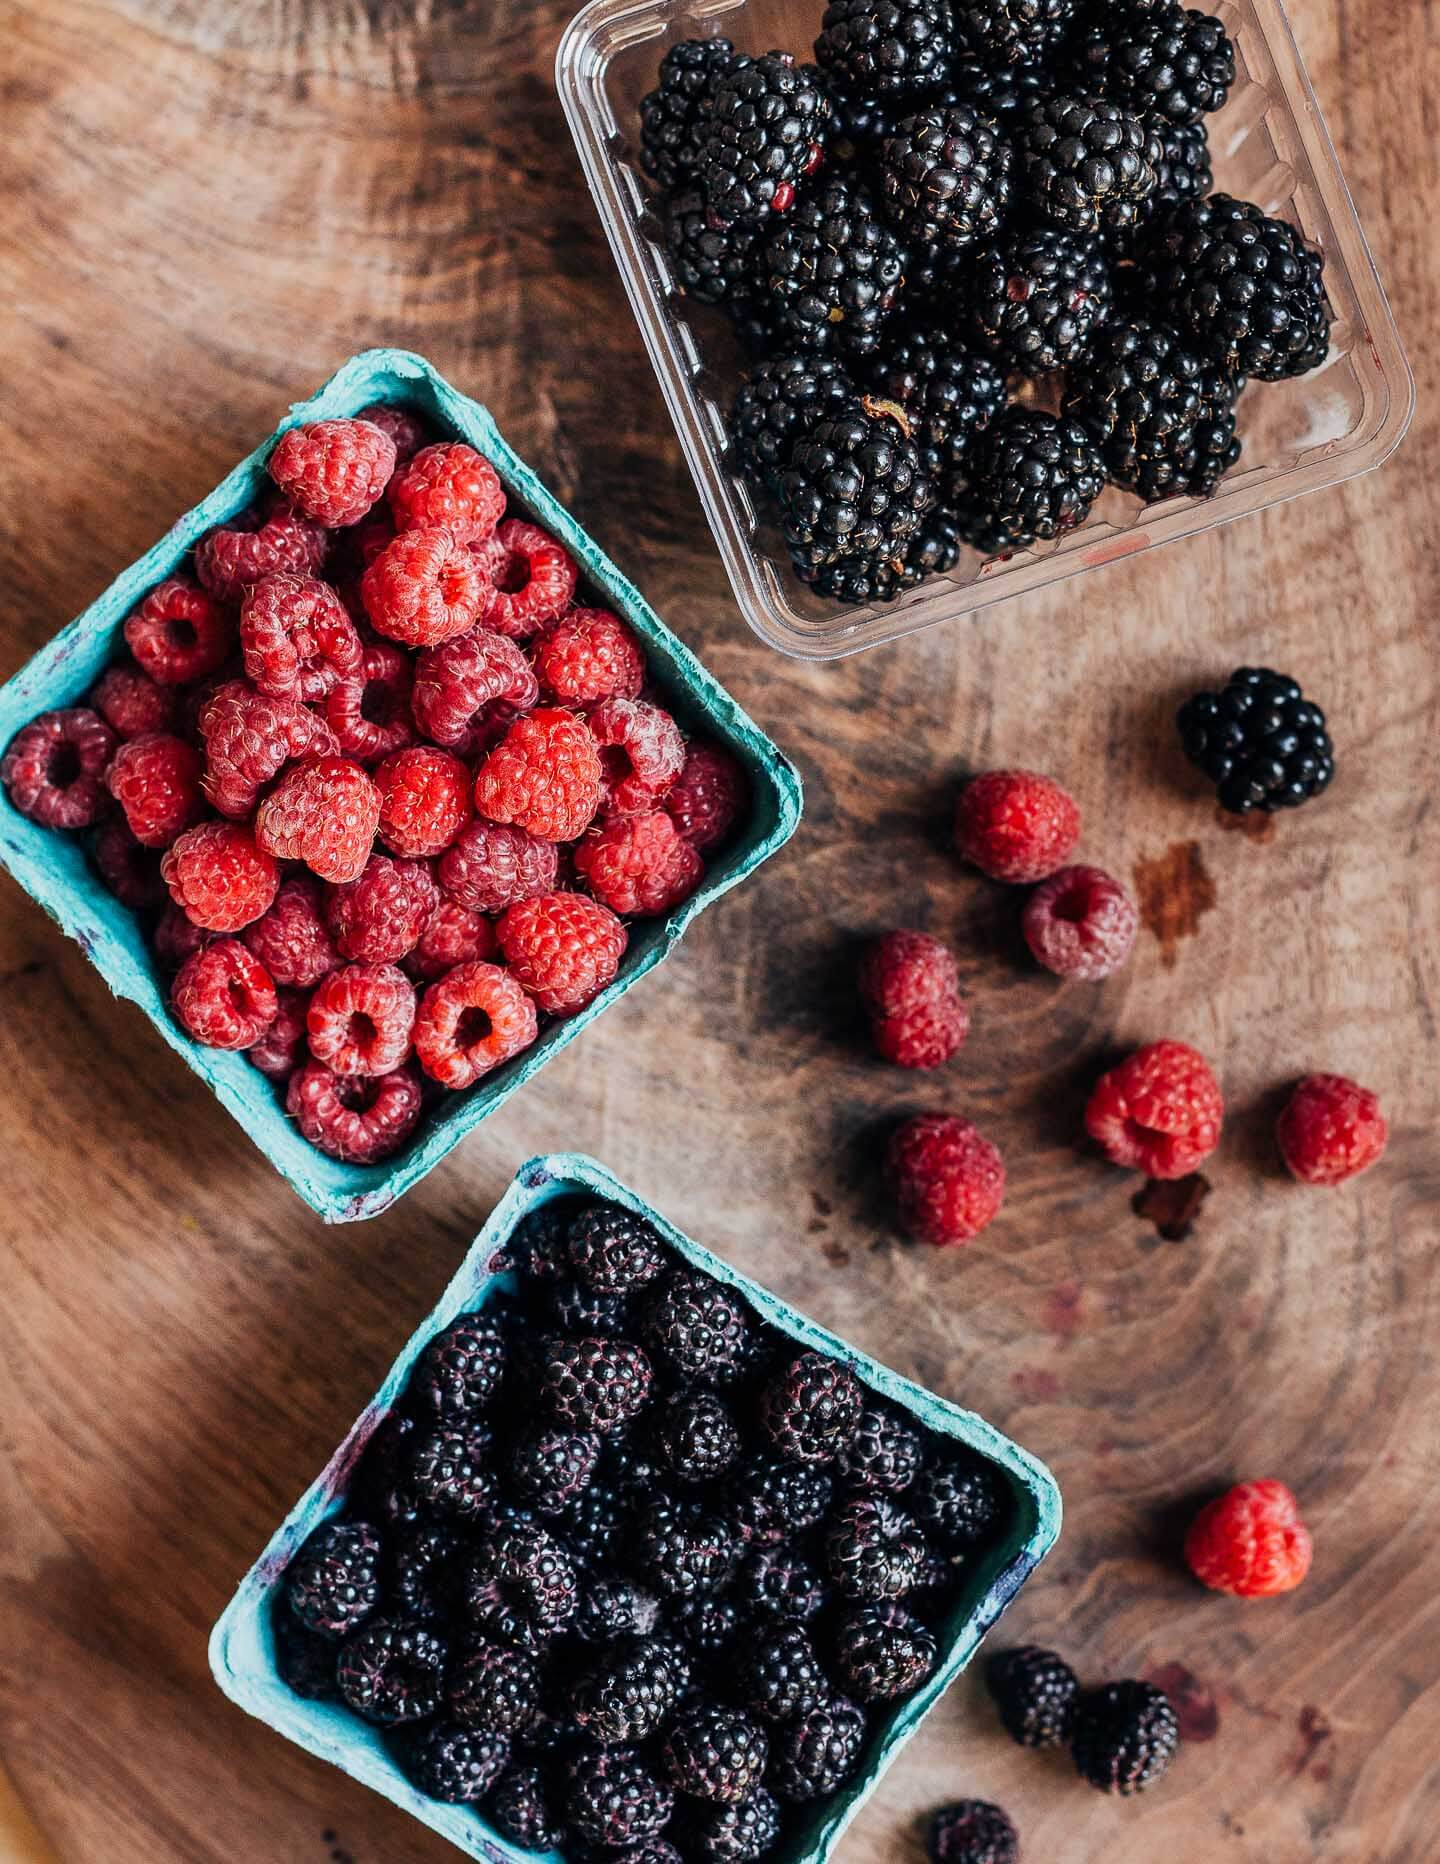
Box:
[211,1154,1060,1864]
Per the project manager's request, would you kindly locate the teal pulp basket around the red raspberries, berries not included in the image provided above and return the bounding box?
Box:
[0,350,801,1223]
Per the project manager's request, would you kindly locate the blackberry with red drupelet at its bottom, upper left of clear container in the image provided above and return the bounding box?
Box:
[697,52,831,220]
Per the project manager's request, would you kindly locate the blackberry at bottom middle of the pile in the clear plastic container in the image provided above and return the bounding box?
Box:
[971,408,1105,546]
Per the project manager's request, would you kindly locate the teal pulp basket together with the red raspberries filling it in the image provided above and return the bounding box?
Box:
[0,350,801,1221]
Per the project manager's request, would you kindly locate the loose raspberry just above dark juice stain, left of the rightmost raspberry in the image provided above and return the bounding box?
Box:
[1084,1042,1224,1178]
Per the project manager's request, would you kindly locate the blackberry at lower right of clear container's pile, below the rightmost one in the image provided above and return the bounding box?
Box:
[1064,321,1241,503]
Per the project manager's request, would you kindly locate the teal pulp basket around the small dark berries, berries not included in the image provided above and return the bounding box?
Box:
[211,1154,1060,1864]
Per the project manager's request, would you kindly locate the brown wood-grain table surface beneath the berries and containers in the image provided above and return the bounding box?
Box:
[0,0,1440,1864]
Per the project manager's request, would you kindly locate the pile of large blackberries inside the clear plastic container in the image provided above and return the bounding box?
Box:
[641,0,1330,602]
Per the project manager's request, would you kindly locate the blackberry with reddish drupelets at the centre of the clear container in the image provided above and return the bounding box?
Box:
[969,227,1112,375]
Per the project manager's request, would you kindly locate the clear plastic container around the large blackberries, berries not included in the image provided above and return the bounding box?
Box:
[555,0,1414,660]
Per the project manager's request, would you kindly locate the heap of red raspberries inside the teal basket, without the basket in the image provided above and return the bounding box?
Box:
[0,406,747,1163]
